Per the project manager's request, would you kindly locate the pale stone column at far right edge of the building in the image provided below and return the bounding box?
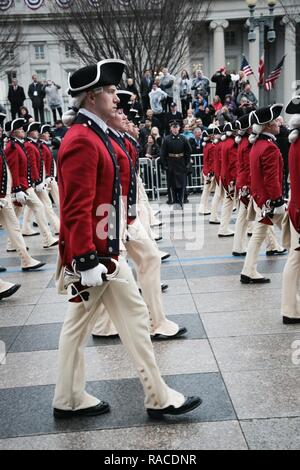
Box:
[282,16,297,109]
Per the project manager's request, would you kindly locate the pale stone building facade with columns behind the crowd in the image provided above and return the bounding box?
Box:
[0,0,300,120]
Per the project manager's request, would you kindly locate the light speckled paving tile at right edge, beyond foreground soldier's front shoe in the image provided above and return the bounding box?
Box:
[222,368,300,420]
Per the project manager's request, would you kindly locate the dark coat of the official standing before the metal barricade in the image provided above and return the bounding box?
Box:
[160,135,191,189]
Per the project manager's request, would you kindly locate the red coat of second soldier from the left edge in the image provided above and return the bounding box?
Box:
[4,139,34,193]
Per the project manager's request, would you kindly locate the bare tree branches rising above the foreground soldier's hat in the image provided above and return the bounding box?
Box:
[51,0,211,85]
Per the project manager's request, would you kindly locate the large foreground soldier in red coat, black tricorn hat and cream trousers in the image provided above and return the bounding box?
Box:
[53,59,201,419]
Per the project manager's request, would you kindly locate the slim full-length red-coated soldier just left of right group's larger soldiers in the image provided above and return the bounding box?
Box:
[218,122,237,238]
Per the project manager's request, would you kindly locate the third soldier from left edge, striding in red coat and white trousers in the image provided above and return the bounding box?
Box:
[23,122,59,235]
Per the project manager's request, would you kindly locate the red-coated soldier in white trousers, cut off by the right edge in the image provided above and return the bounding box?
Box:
[281,96,300,325]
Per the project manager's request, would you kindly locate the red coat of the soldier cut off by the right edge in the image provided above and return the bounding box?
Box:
[289,137,300,233]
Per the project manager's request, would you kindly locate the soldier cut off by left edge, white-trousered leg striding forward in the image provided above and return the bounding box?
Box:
[0,117,45,272]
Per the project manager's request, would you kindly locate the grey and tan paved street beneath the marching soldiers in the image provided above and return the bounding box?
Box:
[0,197,300,450]
